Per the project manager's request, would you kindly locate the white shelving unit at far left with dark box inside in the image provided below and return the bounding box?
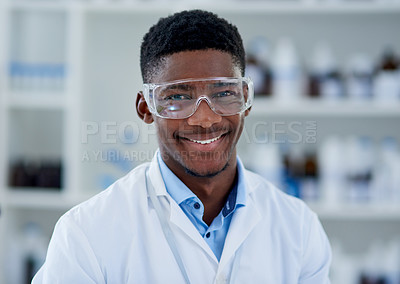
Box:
[0,1,83,283]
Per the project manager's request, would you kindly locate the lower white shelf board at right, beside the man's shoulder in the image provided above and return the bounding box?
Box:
[308,203,400,221]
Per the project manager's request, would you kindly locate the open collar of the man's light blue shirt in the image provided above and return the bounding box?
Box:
[157,152,246,211]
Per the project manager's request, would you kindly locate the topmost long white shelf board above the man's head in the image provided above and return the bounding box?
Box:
[82,0,400,14]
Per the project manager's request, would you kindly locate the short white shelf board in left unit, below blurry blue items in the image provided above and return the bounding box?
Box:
[8,92,67,110]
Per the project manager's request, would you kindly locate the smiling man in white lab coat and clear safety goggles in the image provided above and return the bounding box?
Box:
[33,10,331,284]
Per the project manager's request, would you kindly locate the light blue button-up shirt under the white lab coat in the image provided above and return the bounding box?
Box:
[157,154,246,260]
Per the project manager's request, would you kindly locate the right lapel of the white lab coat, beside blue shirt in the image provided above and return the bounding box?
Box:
[219,186,261,270]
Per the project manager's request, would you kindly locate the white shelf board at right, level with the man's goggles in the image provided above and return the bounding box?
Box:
[251,97,400,118]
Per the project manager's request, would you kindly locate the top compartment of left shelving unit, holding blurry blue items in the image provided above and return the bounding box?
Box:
[7,5,68,94]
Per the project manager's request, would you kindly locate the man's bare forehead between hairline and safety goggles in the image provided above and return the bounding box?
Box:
[152,50,241,83]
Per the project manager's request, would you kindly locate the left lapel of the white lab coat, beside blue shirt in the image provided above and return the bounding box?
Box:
[149,153,218,263]
